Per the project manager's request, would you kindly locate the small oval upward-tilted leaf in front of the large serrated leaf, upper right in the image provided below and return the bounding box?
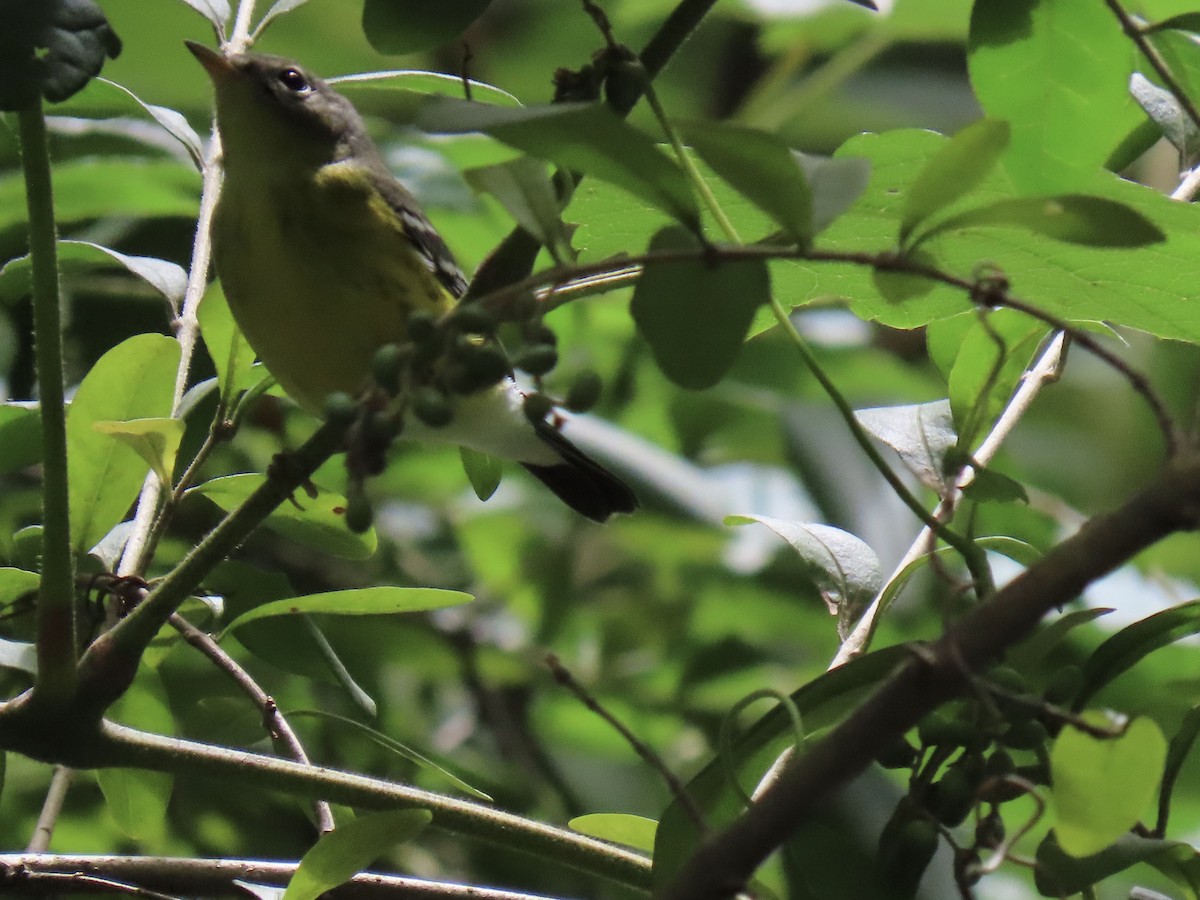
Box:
[900,119,1009,245]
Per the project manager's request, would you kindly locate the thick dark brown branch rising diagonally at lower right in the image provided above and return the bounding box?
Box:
[661,451,1200,900]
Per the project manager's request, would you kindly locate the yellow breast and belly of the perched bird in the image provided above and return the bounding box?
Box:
[214,167,454,413]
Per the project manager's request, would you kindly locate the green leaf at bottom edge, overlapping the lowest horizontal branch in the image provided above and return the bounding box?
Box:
[283,809,433,900]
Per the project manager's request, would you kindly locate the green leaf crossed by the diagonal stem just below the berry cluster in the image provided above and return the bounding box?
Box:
[187,474,379,559]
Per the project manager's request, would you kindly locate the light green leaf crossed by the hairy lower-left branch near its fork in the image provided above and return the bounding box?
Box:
[96,666,175,841]
